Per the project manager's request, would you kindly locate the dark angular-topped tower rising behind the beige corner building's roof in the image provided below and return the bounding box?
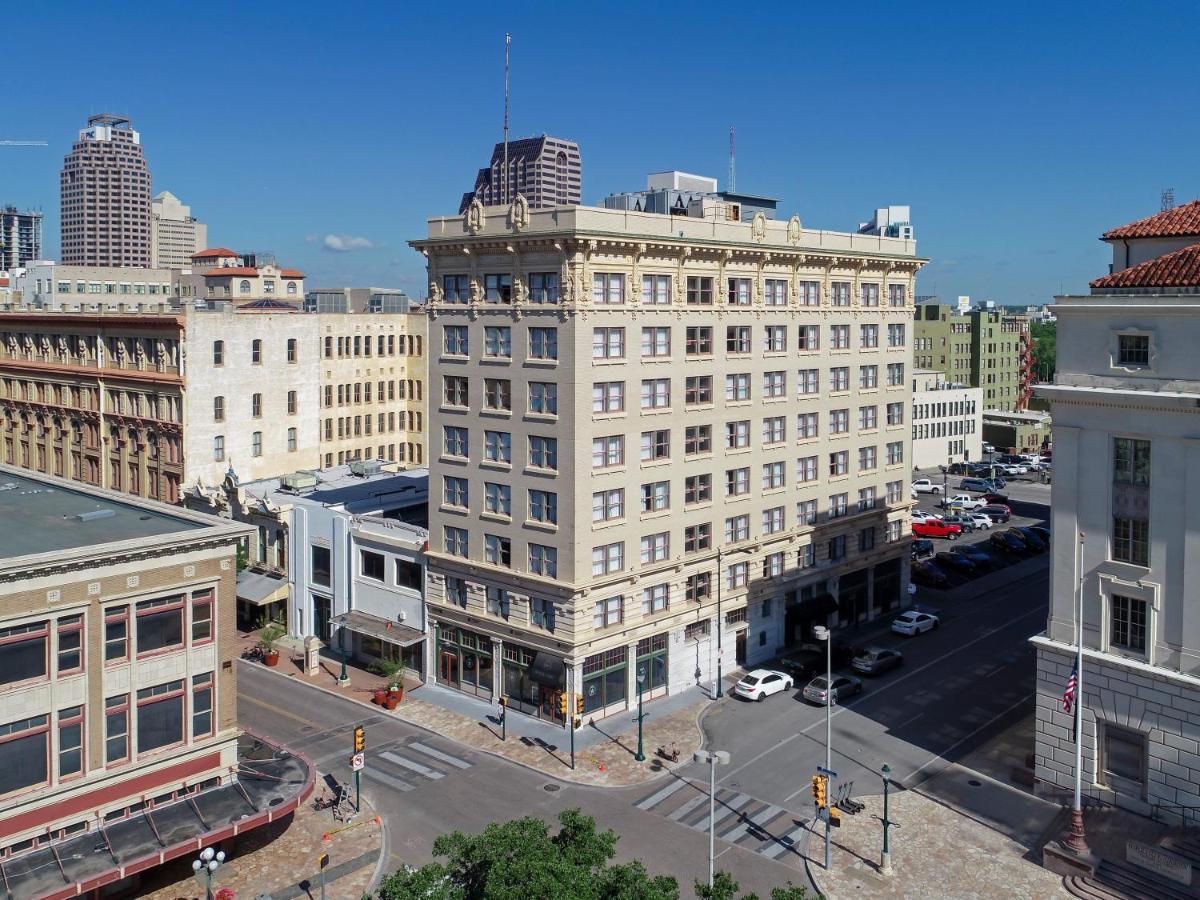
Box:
[458,134,583,215]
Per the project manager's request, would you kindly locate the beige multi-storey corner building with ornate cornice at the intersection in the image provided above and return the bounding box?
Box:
[412,198,924,721]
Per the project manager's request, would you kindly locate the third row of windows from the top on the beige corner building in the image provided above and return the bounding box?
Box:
[442,362,904,424]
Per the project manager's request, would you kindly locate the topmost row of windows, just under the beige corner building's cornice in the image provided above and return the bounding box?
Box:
[442,272,906,306]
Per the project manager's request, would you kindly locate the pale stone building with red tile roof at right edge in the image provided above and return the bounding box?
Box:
[1033,203,1200,820]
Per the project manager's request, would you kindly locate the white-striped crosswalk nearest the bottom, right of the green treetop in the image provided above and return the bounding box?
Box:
[634,778,809,866]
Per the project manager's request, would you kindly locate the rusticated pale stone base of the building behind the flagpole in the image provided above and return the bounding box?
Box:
[1034,637,1200,822]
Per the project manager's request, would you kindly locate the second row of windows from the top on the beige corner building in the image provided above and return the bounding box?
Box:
[442,323,905,360]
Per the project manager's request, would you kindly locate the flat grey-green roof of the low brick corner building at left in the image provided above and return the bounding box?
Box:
[0,467,201,559]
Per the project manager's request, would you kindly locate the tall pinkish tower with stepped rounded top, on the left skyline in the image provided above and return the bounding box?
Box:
[60,113,152,268]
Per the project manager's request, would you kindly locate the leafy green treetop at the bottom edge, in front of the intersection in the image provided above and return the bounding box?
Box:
[378,809,679,900]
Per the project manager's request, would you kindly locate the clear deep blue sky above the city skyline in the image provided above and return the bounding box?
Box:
[9,0,1200,302]
